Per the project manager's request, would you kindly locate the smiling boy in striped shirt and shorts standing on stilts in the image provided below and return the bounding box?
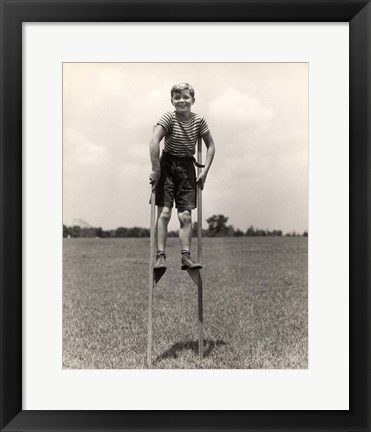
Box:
[149,83,215,270]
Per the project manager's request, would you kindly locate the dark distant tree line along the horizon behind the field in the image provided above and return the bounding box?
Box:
[63,215,308,238]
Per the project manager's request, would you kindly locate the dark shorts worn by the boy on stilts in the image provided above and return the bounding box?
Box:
[156,152,197,210]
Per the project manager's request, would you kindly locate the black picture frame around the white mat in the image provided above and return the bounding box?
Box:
[0,0,371,431]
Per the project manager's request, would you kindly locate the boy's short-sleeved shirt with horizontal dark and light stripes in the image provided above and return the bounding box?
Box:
[157,111,209,157]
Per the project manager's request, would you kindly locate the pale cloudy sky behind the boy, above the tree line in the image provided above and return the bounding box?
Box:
[63,63,308,233]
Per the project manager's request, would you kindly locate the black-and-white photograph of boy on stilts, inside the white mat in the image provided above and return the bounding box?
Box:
[62,62,309,369]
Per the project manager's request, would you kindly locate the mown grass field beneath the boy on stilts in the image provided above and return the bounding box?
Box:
[63,237,308,369]
